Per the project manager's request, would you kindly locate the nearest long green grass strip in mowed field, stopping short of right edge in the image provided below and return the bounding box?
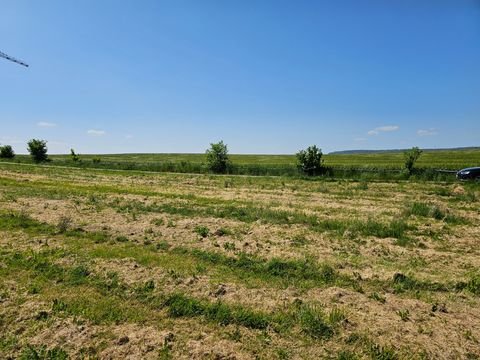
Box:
[3,250,344,338]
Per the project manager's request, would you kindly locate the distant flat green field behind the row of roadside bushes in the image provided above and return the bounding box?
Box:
[4,149,480,177]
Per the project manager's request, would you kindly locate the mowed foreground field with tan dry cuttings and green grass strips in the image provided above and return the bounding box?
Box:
[0,162,480,359]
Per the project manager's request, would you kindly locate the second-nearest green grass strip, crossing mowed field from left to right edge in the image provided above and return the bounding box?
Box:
[0,212,480,294]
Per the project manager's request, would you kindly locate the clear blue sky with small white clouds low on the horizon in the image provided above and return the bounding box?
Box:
[0,0,480,154]
